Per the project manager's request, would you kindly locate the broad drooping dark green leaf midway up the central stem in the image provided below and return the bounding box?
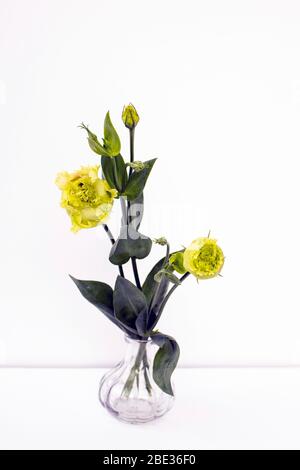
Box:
[109,225,152,266]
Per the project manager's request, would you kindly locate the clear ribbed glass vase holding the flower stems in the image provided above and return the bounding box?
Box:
[99,336,174,424]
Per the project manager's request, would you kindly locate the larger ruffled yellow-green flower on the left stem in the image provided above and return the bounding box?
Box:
[55,165,118,232]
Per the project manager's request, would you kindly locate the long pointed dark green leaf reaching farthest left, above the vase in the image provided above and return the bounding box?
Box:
[70,275,124,331]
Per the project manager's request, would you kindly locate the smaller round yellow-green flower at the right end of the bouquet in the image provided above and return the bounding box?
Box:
[183,238,224,279]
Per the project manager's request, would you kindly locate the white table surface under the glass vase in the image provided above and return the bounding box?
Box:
[0,368,300,450]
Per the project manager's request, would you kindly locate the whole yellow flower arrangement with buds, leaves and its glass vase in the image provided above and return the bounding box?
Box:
[56,104,224,422]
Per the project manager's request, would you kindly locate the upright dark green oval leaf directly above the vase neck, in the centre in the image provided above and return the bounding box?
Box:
[113,276,148,334]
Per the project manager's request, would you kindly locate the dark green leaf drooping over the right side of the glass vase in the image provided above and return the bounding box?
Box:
[151,333,180,395]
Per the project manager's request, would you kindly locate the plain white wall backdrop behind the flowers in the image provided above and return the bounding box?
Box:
[0,0,300,366]
